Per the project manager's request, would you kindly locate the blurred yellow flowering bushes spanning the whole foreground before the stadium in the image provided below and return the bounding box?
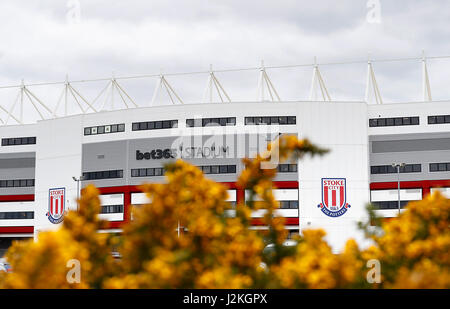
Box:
[0,136,450,288]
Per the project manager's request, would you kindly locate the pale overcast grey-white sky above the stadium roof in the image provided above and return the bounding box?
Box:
[0,0,450,119]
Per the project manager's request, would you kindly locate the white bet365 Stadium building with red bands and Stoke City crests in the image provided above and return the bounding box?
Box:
[0,58,450,250]
